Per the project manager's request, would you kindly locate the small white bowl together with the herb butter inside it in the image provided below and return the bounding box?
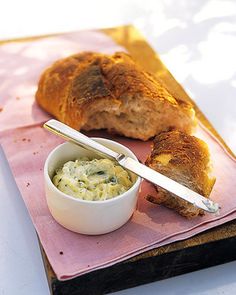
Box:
[44,138,142,235]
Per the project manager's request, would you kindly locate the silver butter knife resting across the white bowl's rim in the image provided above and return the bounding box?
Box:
[44,119,220,213]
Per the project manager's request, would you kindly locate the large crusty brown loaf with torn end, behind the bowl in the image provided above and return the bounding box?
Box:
[36,52,195,140]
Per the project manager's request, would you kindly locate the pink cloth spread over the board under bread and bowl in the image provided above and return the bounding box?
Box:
[0,31,236,280]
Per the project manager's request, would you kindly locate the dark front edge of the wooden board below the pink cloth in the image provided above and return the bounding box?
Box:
[43,222,236,295]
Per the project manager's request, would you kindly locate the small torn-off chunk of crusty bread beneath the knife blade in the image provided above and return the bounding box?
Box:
[146,131,215,218]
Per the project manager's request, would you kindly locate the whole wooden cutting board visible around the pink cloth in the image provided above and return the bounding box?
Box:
[0,26,236,295]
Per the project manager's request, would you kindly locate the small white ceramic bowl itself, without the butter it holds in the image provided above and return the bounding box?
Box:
[44,138,141,235]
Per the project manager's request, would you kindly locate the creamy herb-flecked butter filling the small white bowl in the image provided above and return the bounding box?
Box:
[53,158,133,201]
